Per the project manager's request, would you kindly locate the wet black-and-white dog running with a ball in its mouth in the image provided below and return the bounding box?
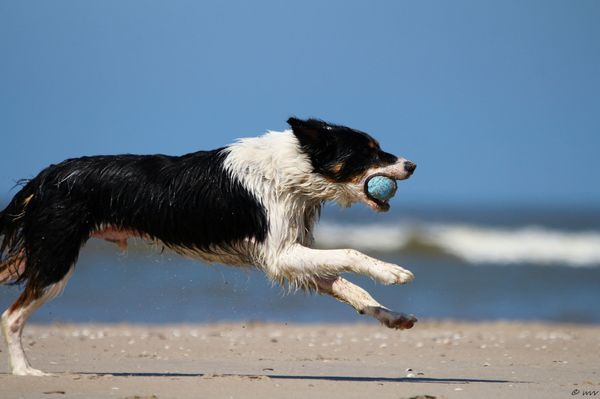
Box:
[0,117,417,376]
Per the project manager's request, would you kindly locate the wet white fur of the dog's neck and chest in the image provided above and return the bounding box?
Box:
[224,130,351,267]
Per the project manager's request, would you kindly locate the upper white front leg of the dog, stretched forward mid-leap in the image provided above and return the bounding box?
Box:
[275,244,414,284]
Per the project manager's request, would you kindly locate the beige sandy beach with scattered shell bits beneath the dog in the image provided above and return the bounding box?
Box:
[0,321,600,399]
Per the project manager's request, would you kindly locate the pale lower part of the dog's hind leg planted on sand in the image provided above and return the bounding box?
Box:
[2,268,73,376]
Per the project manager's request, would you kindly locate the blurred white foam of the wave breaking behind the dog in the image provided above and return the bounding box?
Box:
[316,223,600,267]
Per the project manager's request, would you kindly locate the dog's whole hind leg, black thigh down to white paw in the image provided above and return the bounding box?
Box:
[0,187,86,375]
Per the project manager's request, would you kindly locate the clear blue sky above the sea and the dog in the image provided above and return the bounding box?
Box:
[0,0,600,206]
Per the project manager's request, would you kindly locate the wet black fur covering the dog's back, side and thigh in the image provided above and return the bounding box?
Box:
[0,149,268,295]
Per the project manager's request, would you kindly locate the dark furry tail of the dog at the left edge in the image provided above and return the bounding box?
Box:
[0,181,33,284]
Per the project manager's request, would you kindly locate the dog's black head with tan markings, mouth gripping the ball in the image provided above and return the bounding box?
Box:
[288,118,417,212]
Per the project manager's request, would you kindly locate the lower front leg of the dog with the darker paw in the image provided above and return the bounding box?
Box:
[316,277,417,330]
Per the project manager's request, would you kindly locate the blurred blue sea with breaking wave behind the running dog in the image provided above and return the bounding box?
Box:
[0,204,600,323]
